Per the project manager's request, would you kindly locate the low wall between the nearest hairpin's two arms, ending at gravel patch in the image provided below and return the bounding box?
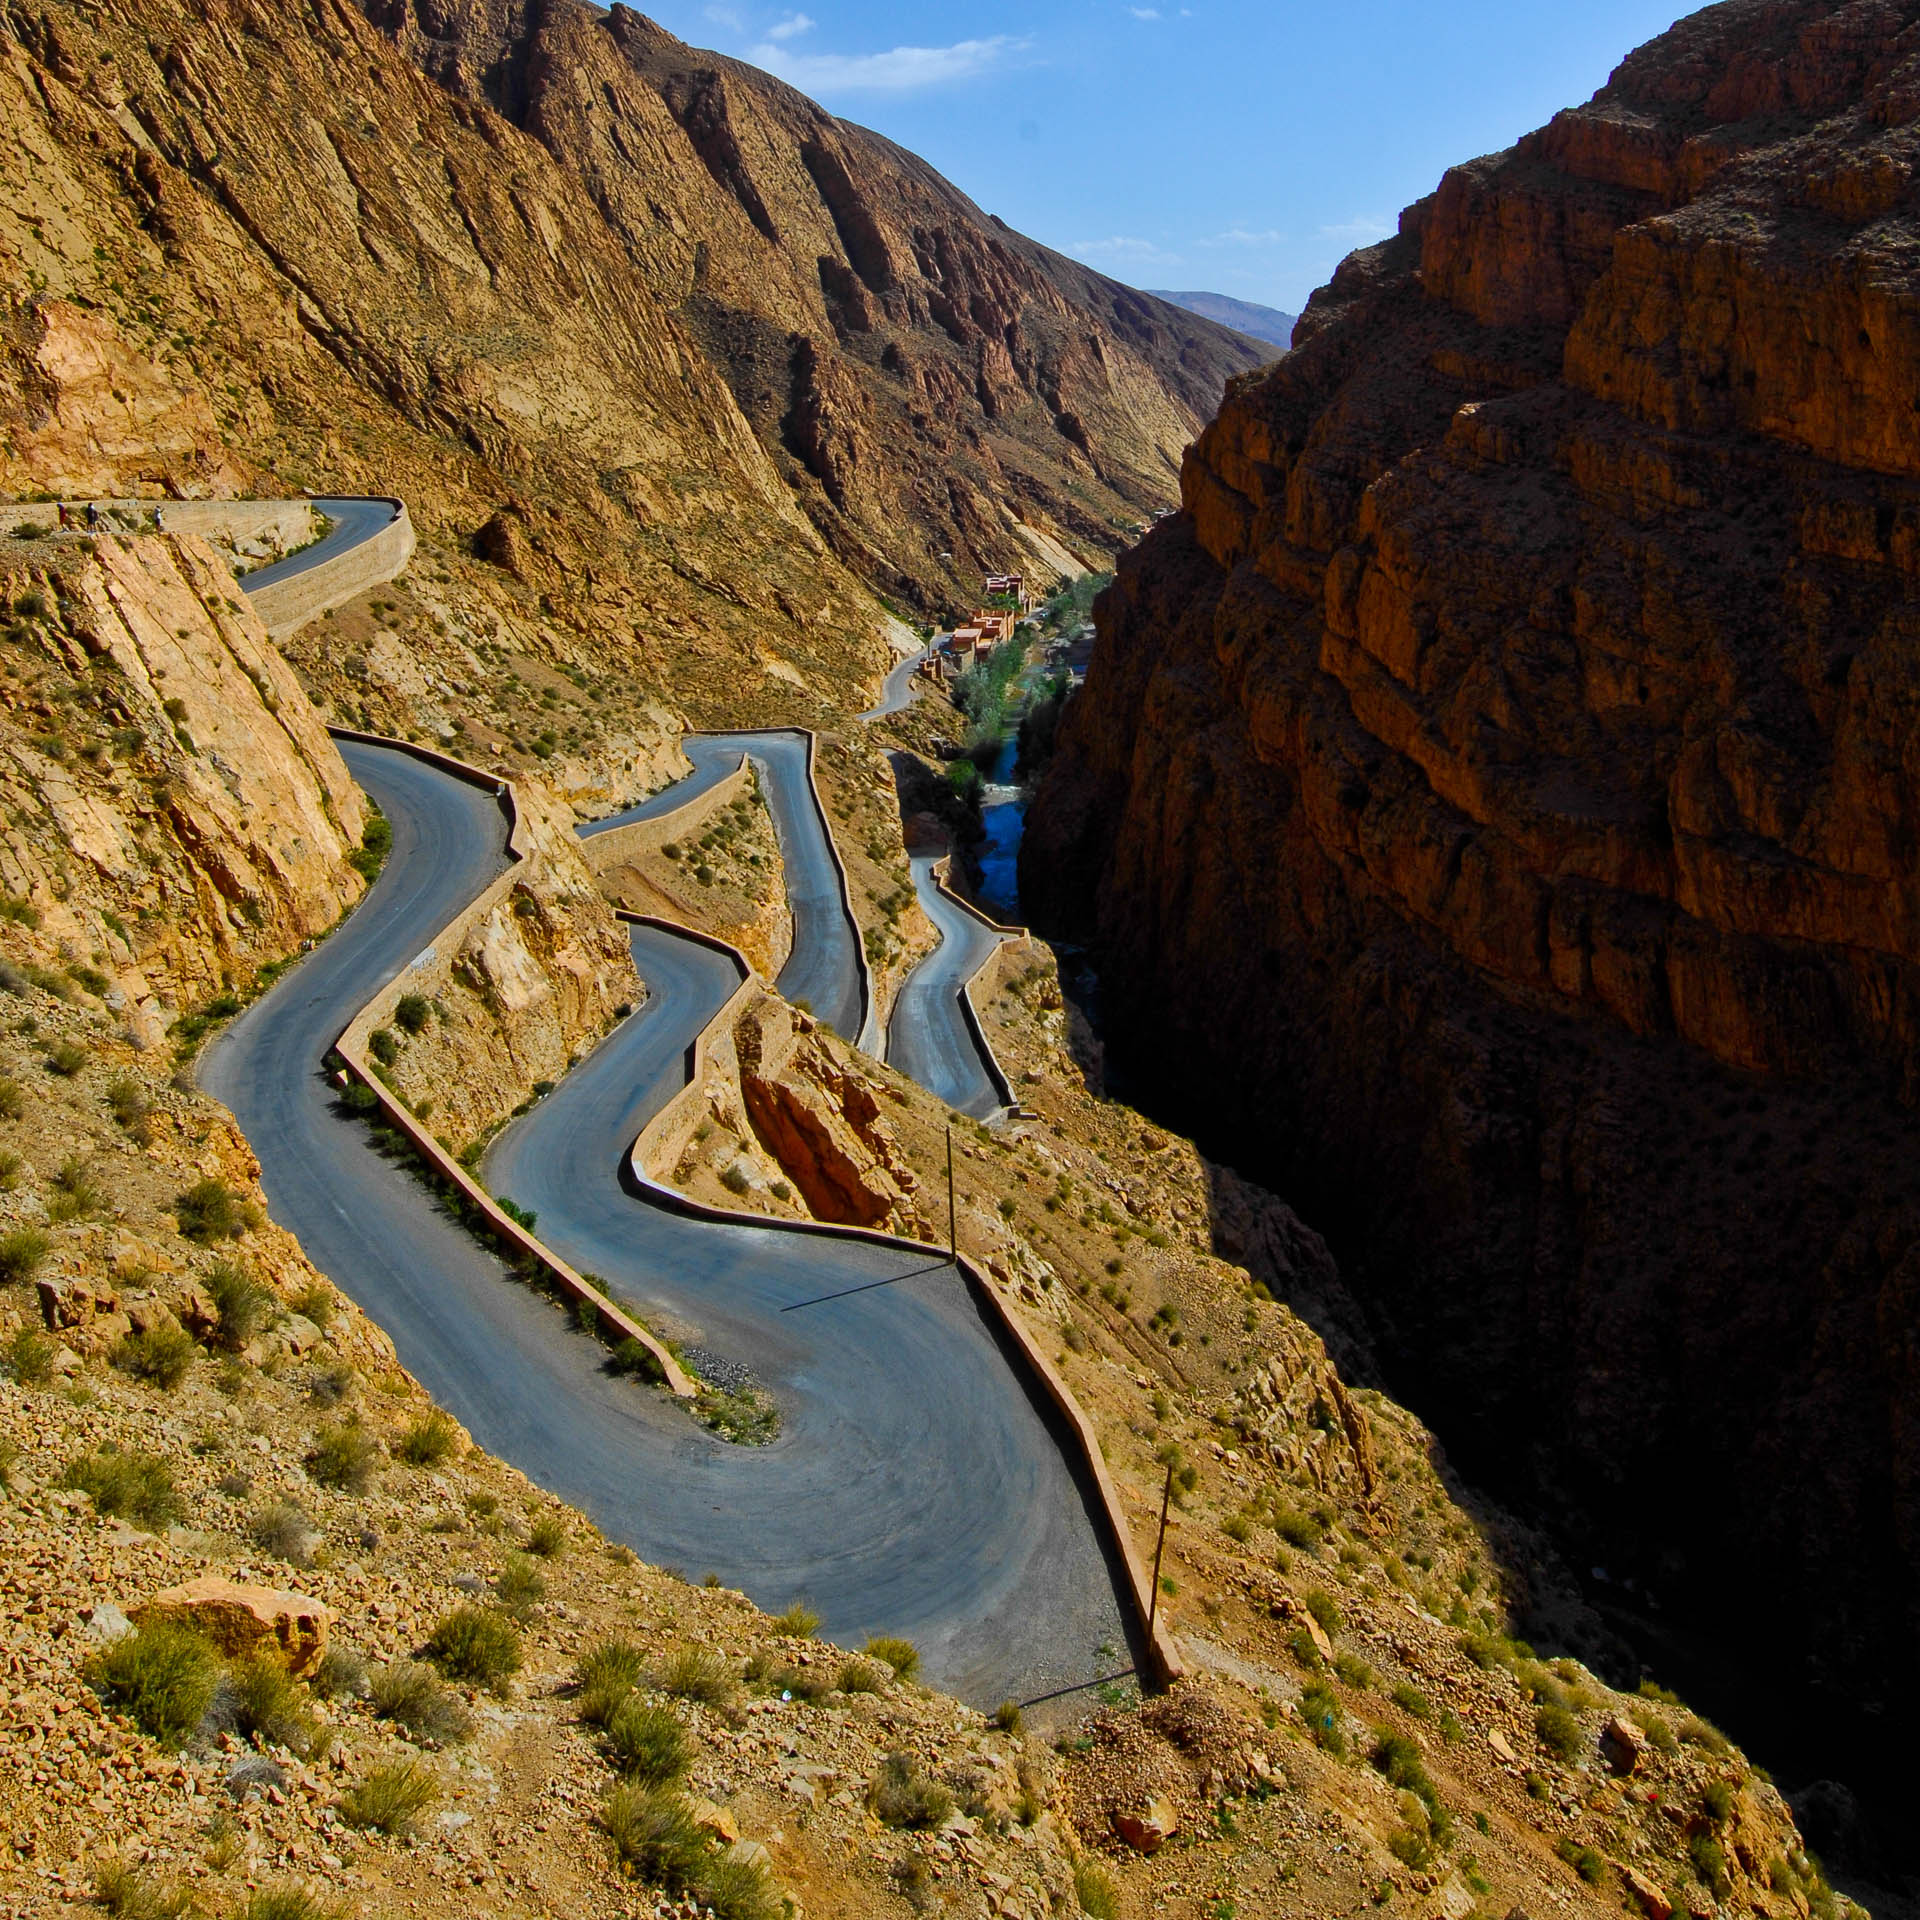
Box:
[326,726,695,1400]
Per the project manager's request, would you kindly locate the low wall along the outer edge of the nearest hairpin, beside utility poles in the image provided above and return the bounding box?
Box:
[614,908,1187,1686]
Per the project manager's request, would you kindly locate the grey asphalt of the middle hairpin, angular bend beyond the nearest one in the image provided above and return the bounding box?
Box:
[580,732,870,1046]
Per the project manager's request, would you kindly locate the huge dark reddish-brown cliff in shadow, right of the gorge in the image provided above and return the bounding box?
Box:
[1023,0,1920,1766]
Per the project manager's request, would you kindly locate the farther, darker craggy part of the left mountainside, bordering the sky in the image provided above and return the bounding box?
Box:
[365,0,1258,611]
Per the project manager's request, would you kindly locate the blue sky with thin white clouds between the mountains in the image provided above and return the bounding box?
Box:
[641,0,1680,313]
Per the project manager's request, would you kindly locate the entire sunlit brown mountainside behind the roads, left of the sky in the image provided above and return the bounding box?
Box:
[0,0,1258,729]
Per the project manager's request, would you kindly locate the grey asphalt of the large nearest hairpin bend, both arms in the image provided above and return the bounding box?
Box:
[200,743,1129,1705]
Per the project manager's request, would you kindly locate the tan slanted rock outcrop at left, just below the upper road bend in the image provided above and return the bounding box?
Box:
[0,536,365,1044]
